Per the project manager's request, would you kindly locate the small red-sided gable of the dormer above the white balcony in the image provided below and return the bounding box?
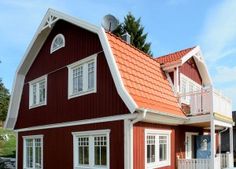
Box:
[180,58,202,85]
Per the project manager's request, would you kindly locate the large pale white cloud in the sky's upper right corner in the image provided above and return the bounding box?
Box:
[200,0,236,62]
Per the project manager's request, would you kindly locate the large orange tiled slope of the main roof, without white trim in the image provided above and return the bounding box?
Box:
[106,33,185,117]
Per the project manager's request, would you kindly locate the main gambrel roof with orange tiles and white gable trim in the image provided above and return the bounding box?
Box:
[5,9,185,129]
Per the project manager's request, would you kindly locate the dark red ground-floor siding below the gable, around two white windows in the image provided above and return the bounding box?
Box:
[18,121,124,169]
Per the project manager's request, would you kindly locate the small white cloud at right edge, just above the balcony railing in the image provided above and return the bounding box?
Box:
[213,66,236,84]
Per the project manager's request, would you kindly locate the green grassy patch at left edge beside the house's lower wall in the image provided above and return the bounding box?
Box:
[0,128,16,158]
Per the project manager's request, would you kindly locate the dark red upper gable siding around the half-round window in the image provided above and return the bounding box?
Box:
[16,21,129,128]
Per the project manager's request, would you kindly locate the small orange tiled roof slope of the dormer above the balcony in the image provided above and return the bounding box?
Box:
[155,47,195,64]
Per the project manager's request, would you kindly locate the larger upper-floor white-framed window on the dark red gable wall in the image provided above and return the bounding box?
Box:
[68,55,97,98]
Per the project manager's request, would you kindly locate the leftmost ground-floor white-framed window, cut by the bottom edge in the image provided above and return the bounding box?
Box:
[23,135,43,169]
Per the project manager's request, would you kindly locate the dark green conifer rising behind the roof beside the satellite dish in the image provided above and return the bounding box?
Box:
[113,12,152,56]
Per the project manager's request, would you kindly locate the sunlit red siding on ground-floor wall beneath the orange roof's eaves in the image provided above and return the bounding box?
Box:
[133,123,203,169]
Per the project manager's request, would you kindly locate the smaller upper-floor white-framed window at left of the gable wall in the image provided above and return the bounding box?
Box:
[29,76,47,108]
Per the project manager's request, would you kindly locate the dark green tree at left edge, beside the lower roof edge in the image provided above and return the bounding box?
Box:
[0,79,10,121]
